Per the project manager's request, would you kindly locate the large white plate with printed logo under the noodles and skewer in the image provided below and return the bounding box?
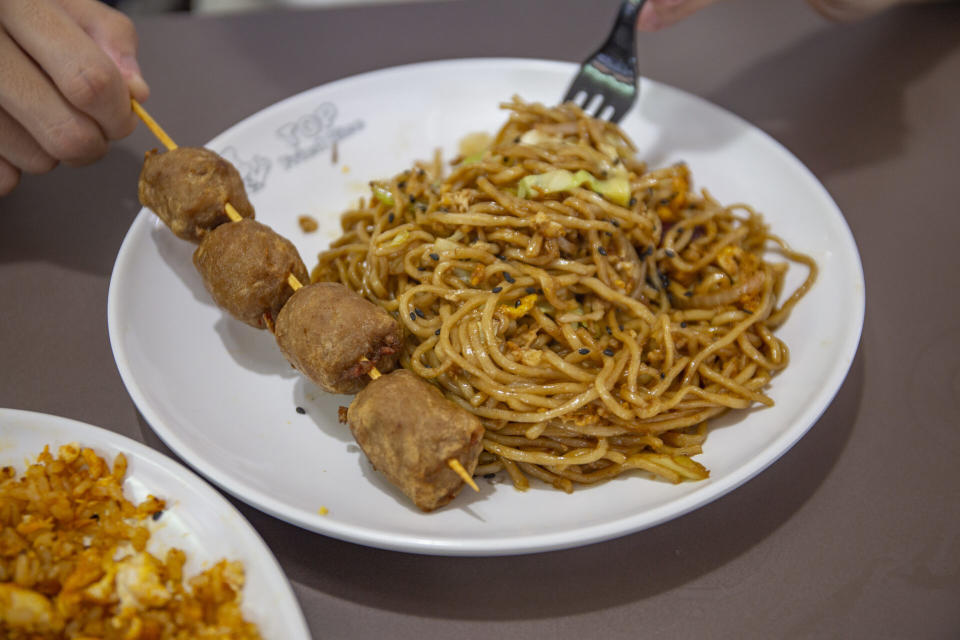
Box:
[108,59,864,555]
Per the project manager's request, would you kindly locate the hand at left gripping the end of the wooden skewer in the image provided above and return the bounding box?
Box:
[0,0,150,196]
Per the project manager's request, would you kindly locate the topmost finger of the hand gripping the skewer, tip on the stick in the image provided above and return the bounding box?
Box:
[59,0,150,102]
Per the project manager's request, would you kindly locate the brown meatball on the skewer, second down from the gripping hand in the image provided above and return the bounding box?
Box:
[193,219,309,329]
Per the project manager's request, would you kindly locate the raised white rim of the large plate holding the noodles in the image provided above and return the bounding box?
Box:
[107,57,866,556]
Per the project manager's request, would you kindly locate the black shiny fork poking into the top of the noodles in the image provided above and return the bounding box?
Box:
[563,0,646,122]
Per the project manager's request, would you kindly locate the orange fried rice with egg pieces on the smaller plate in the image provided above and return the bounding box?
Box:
[0,444,260,640]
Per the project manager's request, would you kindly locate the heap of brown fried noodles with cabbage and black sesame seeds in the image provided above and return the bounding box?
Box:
[312,98,817,491]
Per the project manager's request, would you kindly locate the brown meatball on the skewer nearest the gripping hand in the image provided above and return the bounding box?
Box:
[138,147,254,243]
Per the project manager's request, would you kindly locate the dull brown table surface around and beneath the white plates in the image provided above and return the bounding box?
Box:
[0,0,960,639]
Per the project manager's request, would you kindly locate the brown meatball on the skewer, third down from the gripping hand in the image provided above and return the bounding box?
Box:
[275,282,401,393]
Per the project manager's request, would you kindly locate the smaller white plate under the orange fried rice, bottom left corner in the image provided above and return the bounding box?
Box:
[0,409,310,640]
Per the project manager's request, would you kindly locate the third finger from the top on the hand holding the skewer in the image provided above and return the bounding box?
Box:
[0,27,108,164]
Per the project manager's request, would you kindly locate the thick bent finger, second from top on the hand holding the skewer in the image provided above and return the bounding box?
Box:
[0,0,136,139]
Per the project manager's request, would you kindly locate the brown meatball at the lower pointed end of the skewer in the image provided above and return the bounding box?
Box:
[347,369,483,511]
